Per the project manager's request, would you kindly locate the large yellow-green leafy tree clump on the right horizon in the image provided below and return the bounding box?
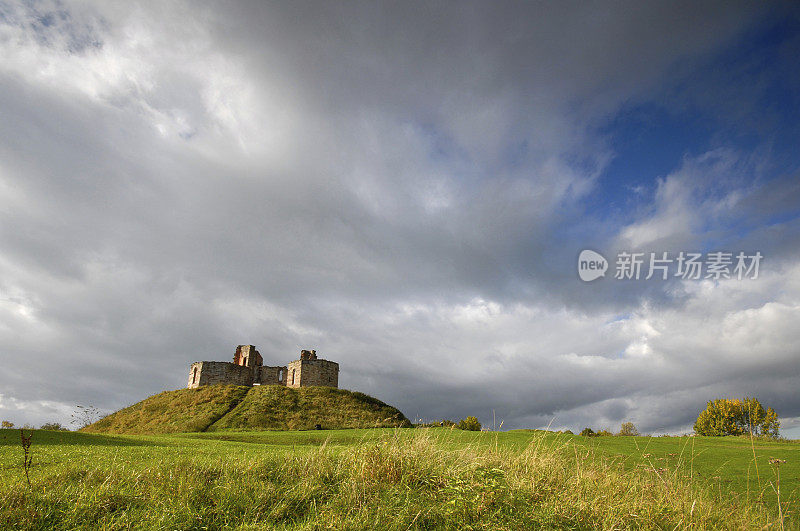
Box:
[694,397,780,438]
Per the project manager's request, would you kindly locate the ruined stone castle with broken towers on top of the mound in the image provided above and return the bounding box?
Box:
[188,345,339,389]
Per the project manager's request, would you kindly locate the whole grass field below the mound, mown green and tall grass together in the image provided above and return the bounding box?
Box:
[0,428,800,529]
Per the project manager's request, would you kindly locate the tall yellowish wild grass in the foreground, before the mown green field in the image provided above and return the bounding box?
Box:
[0,430,779,529]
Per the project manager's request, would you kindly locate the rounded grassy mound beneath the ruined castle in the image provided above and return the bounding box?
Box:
[84,385,409,434]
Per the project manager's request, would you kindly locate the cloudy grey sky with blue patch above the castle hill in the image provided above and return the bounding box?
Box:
[0,1,800,437]
